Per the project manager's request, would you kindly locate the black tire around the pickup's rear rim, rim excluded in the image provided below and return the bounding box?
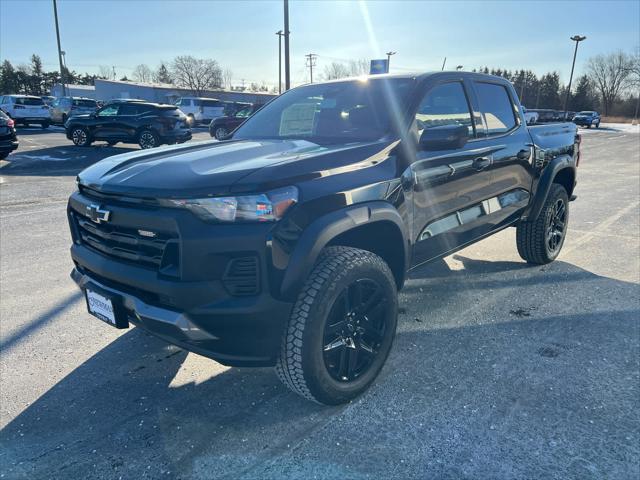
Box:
[516,183,569,265]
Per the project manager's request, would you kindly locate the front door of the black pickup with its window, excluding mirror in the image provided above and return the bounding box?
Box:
[410,80,492,265]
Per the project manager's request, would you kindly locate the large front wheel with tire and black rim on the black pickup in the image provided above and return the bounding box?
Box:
[276,247,398,405]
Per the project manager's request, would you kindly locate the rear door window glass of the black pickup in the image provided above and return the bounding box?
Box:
[475,82,518,136]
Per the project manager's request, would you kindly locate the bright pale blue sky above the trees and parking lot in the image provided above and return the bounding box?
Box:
[0,0,640,85]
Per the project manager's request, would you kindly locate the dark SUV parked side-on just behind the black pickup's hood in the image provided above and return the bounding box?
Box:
[64,102,191,149]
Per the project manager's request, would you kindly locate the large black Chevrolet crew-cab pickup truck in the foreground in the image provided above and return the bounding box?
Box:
[68,72,580,404]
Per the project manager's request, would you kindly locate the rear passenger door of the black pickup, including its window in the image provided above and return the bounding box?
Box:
[471,80,534,227]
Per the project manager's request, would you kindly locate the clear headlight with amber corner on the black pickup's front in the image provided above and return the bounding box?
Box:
[163,187,298,222]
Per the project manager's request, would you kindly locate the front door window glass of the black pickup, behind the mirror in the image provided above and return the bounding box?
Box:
[416,82,474,138]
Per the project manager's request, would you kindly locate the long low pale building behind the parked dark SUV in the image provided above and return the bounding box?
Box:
[51,79,276,104]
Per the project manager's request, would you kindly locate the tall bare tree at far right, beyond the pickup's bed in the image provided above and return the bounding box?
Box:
[587,51,632,115]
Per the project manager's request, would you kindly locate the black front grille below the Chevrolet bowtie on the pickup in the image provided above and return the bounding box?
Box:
[73,214,179,275]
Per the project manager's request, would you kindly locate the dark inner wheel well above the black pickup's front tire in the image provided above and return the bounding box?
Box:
[326,221,405,290]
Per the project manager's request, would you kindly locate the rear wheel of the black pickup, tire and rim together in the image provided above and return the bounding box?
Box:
[516,183,569,265]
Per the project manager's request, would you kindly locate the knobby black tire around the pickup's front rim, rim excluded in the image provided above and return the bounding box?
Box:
[275,247,398,405]
